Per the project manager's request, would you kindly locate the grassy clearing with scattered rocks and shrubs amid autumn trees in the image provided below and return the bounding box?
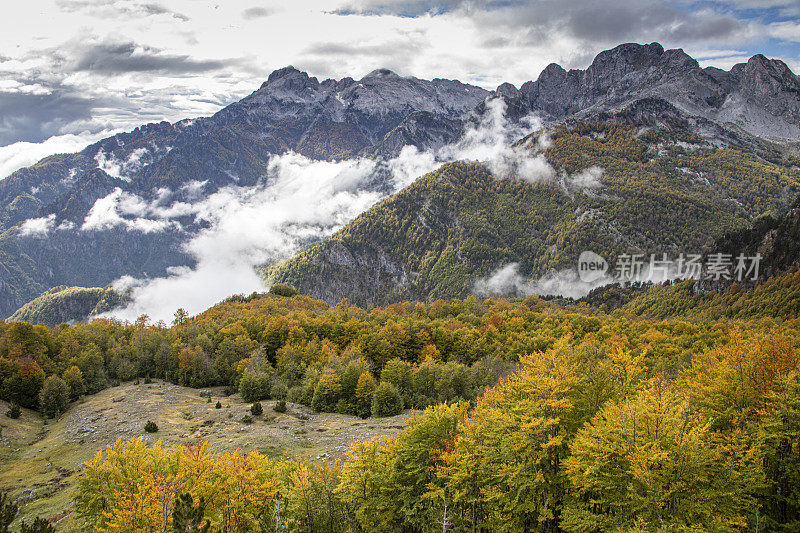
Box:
[0,382,410,531]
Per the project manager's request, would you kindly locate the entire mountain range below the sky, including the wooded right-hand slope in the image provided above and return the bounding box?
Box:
[0,43,800,320]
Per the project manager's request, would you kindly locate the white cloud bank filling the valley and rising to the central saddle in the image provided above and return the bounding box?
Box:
[100,95,554,320]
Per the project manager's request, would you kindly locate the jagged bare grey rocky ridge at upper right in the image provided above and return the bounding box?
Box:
[510,43,800,140]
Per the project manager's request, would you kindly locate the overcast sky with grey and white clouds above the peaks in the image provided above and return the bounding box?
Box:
[0,0,800,178]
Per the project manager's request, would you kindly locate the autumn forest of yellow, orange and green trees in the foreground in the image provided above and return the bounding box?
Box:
[0,273,800,532]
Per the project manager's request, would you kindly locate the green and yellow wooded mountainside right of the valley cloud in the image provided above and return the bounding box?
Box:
[269,106,800,305]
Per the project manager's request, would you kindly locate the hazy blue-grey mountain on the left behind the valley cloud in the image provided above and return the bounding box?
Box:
[0,67,488,316]
